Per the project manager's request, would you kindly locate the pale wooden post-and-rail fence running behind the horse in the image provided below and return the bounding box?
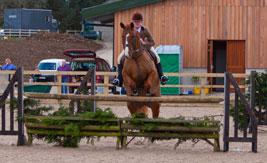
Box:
[0,70,249,96]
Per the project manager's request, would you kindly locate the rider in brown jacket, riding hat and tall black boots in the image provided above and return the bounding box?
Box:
[112,13,168,86]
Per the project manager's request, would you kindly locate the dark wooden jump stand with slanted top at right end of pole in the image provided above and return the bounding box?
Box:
[223,72,258,152]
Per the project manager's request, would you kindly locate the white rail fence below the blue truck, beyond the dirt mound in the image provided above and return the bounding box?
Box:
[4,29,50,38]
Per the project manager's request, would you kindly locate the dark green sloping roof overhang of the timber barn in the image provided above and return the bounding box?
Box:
[81,0,162,22]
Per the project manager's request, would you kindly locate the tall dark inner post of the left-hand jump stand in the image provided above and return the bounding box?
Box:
[17,67,25,146]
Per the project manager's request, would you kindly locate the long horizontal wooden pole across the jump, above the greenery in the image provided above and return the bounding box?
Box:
[24,93,223,103]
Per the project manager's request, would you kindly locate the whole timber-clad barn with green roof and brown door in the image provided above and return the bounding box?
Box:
[82,0,267,73]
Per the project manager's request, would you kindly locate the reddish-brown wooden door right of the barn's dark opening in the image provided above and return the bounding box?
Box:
[226,41,245,92]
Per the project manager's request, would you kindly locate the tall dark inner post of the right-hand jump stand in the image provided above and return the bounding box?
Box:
[223,72,230,152]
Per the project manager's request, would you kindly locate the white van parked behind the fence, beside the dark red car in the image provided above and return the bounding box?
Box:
[34,59,66,82]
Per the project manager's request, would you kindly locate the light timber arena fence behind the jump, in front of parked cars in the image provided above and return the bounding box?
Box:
[0,71,248,97]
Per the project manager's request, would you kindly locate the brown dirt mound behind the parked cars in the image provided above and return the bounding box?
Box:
[0,33,102,70]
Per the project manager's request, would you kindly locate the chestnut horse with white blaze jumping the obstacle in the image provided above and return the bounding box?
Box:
[120,23,160,118]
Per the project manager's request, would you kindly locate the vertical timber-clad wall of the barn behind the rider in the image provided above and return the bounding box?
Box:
[114,0,267,68]
